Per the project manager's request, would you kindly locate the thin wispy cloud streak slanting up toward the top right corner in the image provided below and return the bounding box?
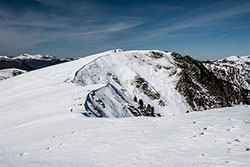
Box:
[122,3,250,42]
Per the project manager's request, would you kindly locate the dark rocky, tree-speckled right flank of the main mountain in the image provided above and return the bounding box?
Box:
[172,52,250,110]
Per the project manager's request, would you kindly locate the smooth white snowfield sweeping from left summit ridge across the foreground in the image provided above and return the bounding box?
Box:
[0,52,250,167]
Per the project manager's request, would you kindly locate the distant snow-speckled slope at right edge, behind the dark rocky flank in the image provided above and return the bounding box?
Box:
[203,56,250,90]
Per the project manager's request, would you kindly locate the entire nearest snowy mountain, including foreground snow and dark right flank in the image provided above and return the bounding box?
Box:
[0,50,250,167]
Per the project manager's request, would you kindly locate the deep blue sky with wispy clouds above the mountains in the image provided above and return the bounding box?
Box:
[0,0,250,59]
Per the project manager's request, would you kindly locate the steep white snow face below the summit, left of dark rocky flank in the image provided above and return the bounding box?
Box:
[73,51,188,115]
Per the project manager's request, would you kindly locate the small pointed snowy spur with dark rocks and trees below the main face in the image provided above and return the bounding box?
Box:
[83,83,161,118]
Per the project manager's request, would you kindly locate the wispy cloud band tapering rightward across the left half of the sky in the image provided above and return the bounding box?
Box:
[0,3,143,55]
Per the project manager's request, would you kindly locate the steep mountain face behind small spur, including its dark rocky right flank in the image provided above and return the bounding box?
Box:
[73,51,250,116]
